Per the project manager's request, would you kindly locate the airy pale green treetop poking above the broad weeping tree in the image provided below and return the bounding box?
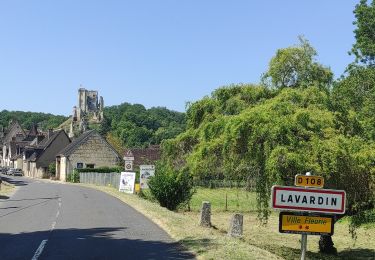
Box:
[262,37,333,88]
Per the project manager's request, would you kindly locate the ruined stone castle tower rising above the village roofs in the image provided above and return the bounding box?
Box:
[69,88,104,137]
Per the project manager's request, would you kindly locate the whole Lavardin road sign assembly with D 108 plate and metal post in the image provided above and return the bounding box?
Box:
[271,172,346,260]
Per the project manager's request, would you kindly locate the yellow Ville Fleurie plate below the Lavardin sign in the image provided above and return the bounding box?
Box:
[279,212,334,235]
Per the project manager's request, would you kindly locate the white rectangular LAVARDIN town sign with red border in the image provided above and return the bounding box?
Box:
[272,186,346,214]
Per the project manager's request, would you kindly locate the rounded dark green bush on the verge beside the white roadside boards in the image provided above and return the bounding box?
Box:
[148,163,195,210]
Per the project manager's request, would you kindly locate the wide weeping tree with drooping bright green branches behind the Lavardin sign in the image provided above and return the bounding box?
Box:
[163,85,375,252]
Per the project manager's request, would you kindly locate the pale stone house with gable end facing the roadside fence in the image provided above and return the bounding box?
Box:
[56,130,121,181]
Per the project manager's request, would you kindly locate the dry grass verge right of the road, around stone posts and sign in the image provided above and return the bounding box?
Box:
[81,184,375,260]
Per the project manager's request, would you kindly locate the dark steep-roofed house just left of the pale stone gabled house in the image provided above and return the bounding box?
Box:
[22,130,71,178]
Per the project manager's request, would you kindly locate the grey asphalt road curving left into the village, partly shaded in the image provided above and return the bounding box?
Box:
[0,175,194,260]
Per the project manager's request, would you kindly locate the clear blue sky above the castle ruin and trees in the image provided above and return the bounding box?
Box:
[0,0,359,115]
